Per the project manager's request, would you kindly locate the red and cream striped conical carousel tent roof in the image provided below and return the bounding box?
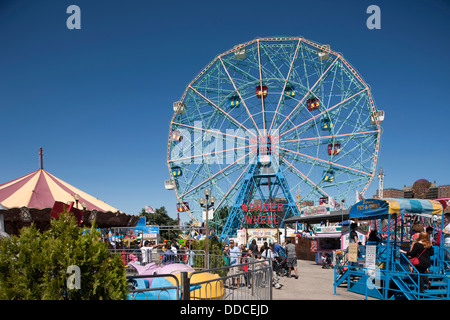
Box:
[0,169,119,212]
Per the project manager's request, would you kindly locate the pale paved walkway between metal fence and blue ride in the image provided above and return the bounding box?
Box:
[273,260,376,300]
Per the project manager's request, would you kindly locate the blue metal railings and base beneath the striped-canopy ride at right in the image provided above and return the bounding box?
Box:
[334,245,450,300]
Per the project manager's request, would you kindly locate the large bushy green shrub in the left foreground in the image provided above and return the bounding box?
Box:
[0,213,127,300]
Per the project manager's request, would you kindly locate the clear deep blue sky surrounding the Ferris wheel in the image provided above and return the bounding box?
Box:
[0,0,450,220]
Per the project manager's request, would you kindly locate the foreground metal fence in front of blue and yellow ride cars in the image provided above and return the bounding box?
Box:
[123,251,273,300]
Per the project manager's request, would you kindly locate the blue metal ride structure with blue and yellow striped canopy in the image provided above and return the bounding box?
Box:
[334,199,450,300]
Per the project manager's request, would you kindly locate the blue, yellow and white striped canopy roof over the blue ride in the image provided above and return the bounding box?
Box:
[350,198,443,219]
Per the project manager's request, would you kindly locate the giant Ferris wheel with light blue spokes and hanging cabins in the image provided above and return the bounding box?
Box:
[165,37,384,229]
